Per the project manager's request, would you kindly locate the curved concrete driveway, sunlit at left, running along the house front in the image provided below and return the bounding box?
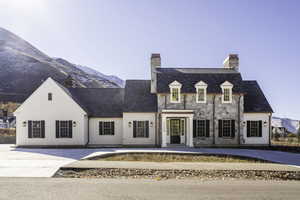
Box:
[0,144,300,177]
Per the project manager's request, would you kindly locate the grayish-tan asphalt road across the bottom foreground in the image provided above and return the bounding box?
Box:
[0,178,300,200]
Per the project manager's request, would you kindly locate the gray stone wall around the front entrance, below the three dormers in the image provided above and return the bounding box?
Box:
[157,94,244,146]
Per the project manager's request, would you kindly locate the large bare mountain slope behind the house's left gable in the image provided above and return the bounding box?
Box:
[0,28,124,102]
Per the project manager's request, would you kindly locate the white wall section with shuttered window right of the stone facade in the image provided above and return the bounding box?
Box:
[243,113,270,145]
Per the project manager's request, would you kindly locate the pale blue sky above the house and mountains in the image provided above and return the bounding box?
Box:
[0,0,300,119]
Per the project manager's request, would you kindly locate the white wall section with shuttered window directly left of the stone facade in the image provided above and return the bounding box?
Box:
[123,113,156,145]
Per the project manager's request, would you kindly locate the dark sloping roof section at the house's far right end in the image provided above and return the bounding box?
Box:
[243,81,273,113]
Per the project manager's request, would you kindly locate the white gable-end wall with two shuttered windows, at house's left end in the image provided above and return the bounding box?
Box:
[14,78,87,146]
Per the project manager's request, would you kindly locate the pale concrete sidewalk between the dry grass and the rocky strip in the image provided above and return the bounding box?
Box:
[61,160,300,171]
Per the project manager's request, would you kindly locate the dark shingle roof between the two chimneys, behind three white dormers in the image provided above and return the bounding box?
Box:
[156,68,243,93]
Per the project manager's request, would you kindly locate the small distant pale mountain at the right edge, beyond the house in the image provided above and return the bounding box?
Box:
[272,117,300,134]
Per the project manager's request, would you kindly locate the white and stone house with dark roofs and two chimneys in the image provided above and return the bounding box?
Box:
[14,54,273,147]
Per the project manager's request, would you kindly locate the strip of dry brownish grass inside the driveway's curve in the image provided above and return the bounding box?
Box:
[93,153,267,163]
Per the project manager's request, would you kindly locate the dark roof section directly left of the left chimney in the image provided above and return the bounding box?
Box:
[123,80,157,112]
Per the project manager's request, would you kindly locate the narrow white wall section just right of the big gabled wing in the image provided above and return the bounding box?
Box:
[89,118,123,145]
